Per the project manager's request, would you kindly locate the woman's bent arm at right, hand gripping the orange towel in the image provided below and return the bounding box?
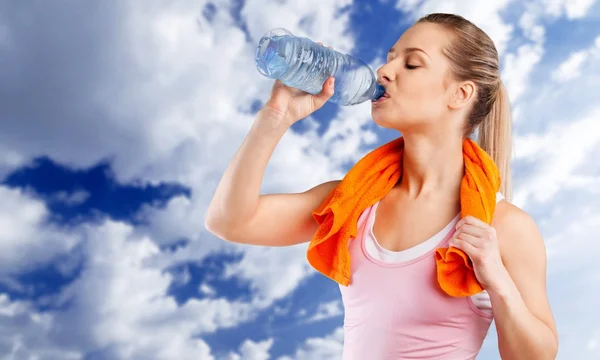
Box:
[450,202,558,360]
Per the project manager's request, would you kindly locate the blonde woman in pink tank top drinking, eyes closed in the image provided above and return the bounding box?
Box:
[206,14,558,360]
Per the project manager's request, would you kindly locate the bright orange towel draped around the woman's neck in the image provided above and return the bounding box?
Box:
[307,137,500,296]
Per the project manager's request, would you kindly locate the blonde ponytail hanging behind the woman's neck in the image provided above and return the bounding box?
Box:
[477,82,513,201]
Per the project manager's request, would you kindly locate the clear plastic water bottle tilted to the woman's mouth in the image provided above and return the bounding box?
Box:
[255,28,385,105]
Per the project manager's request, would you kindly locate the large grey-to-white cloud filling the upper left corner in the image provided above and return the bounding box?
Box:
[0,0,256,186]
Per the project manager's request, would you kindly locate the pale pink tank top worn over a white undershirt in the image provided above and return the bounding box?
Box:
[339,201,493,360]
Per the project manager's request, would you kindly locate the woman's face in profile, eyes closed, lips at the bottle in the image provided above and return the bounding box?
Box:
[371,23,455,132]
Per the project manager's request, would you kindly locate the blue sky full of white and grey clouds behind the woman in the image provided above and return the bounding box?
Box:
[0,0,600,360]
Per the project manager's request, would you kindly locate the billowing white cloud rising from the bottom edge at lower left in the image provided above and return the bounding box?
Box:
[0,214,278,359]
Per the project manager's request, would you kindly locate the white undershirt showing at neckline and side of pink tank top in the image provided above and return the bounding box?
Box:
[365,192,504,313]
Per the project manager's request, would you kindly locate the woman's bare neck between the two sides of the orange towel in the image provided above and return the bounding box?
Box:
[397,133,464,199]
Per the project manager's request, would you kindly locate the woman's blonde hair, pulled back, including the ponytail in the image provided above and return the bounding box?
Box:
[417,13,513,201]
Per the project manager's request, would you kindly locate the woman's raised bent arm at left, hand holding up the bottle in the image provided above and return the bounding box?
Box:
[205,75,339,246]
